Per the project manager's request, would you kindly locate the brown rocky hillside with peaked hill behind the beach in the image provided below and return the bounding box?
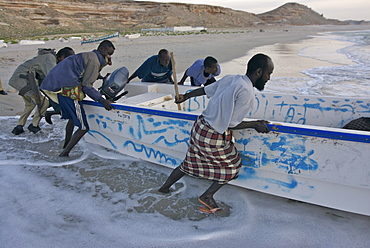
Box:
[0,0,345,39]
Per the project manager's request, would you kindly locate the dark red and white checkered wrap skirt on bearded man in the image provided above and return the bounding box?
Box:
[180,116,242,184]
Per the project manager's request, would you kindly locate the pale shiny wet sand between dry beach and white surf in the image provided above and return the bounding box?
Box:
[222,35,355,78]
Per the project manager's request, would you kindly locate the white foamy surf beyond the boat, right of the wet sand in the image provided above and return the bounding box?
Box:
[299,30,370,97]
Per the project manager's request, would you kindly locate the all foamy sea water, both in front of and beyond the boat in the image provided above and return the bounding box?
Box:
[0,31,370,247]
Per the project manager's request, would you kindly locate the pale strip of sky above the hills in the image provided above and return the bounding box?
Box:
[137,0,370,21]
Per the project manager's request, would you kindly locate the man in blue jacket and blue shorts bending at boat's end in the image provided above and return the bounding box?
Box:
[41,40,115,157]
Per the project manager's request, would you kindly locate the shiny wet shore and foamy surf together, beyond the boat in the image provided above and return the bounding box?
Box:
[221,27,370,97]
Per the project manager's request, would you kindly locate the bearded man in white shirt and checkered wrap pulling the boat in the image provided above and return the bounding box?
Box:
[159,54,274,213]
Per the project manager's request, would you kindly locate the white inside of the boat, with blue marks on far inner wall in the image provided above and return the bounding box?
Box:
[111,82,370,131]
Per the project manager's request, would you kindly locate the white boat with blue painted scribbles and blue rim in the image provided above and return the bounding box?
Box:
[83,82,370,216]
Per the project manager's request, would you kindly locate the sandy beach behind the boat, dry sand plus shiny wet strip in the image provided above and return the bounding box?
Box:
[0,25,370,116]
